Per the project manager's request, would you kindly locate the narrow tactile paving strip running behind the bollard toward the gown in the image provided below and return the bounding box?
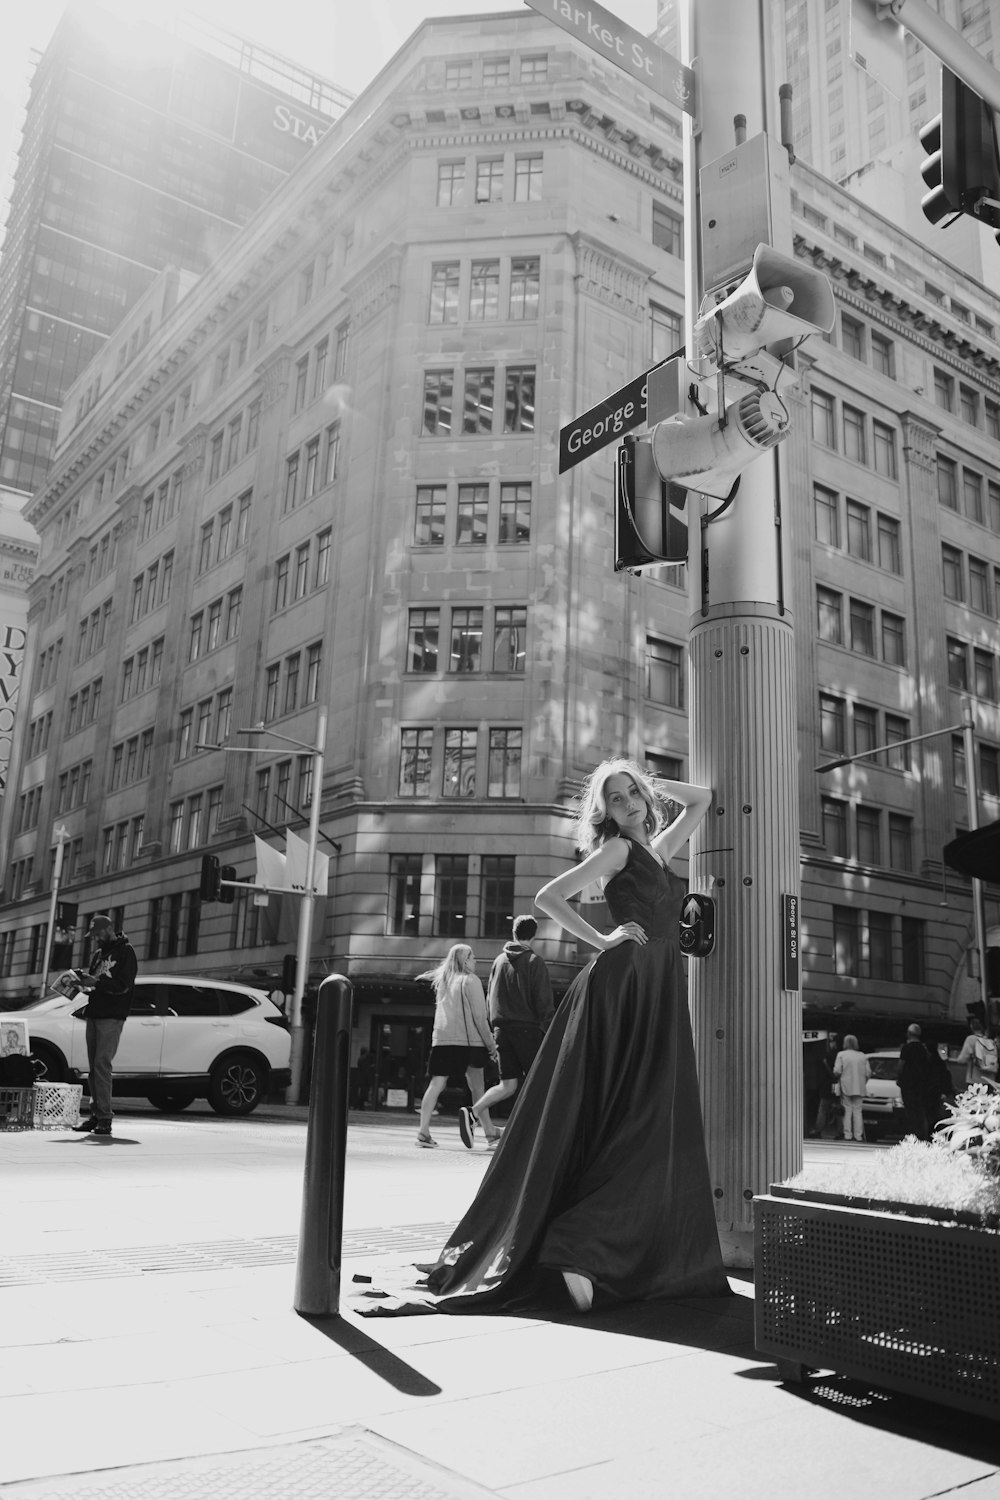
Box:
[0,1224,454,1287]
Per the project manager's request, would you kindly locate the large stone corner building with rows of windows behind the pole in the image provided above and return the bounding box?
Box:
[0,12,1000,1085]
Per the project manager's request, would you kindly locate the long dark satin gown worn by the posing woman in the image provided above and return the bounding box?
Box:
[427,840,729,1313]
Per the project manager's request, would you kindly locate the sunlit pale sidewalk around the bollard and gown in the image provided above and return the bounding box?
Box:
[0,1116,1000,1500]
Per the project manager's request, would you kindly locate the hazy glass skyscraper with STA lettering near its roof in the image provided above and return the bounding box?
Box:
[0,6,351,495]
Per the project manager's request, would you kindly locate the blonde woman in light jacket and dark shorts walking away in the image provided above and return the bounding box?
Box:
[417,942,499,1148]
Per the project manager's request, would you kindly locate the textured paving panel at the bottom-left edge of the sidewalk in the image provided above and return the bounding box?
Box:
[3,1428,495,1500]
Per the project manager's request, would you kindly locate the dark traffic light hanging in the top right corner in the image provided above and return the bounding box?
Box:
[921,68,1000,230]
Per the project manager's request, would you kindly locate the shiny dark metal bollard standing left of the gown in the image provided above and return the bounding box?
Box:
[294,974,352,1317]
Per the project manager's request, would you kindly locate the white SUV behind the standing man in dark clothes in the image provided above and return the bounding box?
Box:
[18,974,291,1115]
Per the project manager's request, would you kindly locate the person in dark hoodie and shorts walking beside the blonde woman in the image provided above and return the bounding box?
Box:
[459,917,553,1151]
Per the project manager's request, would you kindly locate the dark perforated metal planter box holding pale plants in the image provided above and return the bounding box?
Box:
[754,1187,1000,1421]
